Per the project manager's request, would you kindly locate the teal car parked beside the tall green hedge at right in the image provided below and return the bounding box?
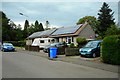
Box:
[79,40,102,58]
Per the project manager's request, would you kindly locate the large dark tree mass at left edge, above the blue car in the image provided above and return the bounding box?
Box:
[0,12,23,41]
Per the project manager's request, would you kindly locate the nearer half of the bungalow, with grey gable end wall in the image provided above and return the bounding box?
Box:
[50,22,95,45]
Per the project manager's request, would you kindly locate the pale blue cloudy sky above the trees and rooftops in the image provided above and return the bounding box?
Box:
[0,0,118,28]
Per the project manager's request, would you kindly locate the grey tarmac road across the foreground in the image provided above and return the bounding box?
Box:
[2,51,118,78]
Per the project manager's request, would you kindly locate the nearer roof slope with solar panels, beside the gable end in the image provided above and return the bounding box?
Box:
[52,24,83,35]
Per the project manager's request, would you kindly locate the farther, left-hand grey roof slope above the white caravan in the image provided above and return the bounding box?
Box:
[27,29,56,39]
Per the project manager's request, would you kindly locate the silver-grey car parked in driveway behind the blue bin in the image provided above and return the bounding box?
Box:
[43,42,67,53]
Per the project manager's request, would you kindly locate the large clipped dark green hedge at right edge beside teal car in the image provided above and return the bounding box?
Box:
[101,35,120,64]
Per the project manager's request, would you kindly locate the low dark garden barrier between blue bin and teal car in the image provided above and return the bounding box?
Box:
[65,48,80,56]
